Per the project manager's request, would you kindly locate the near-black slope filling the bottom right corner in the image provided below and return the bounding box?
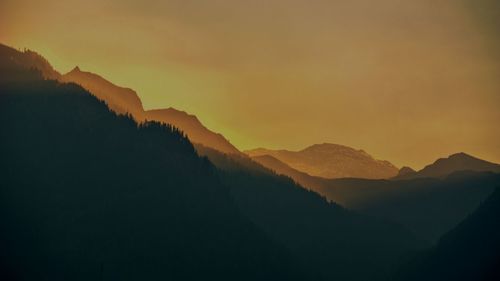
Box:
[393,188,500,281]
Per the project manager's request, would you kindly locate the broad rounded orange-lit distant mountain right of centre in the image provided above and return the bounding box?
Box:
[245,143,398,179]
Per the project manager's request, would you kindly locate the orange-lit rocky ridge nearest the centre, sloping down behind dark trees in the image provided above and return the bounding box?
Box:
[144,107,241,154]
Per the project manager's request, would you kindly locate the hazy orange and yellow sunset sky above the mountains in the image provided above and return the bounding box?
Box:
[0,0,500,169]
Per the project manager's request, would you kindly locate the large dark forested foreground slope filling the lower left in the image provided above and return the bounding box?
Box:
[0,75,309,280]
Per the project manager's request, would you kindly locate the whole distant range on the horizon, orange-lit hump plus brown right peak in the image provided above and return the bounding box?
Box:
[245,144,500,184]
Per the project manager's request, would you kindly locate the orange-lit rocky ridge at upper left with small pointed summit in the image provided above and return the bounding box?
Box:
[60,66,144,117]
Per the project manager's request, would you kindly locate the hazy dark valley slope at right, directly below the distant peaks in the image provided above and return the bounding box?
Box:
[252,149,500,242]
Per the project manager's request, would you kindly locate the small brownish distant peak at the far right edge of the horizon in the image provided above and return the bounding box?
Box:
[397,153,500,179]
